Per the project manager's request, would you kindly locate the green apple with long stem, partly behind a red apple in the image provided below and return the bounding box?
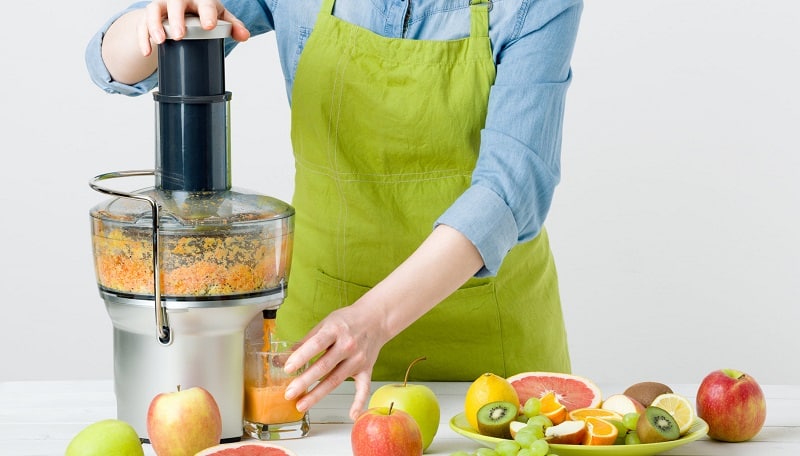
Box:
[368,356,439,451]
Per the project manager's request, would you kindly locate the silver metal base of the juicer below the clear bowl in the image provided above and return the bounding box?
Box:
[101,289,285,442]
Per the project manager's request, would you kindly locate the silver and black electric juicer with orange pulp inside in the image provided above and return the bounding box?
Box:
[90,17,294,442]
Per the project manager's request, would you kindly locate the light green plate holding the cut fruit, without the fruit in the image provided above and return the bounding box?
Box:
[450,413,708,456]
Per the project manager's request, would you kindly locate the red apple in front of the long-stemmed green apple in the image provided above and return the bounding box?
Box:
[350,404,422,456]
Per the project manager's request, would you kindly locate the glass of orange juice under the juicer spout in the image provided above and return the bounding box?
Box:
[243,340,310,440]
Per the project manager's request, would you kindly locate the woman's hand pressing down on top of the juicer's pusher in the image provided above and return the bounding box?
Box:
[136,0,250,56]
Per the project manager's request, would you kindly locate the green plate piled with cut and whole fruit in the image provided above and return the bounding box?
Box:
[449,372,708,456]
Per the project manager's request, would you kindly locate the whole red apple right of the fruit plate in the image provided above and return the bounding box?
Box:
[697,369,767,442]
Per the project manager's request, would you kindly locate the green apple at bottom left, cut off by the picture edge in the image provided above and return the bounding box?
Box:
[65,419,144,456]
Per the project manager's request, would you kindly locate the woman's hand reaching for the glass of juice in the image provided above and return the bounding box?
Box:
[285,297,389,420]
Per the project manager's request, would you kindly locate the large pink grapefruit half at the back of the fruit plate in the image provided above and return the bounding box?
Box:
[508,372,602,412]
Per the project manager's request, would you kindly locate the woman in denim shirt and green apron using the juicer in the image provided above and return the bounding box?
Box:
[87,0,582,418]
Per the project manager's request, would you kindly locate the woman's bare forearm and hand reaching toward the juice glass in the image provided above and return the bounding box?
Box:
[286,225,483,419]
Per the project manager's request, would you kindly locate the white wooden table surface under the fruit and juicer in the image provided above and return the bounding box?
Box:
[0,380,800,456]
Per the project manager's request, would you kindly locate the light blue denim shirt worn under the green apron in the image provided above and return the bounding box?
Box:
[86,0,583,276]
